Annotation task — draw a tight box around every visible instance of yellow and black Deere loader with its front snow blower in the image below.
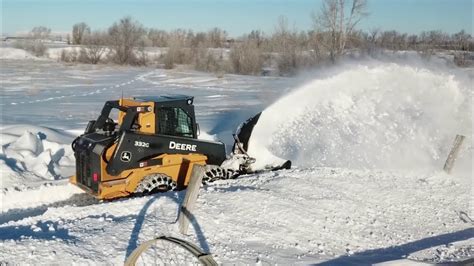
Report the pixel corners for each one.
[70,95,291,199]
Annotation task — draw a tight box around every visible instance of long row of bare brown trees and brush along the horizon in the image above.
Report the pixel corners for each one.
[12,0,474,75]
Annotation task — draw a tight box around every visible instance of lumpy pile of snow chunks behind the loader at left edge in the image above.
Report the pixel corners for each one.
[0,125,75,188]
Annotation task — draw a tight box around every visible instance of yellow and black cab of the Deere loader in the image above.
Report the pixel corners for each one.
[86,95,199,139]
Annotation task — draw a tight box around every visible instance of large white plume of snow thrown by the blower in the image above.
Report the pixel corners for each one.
[249,63,472,172]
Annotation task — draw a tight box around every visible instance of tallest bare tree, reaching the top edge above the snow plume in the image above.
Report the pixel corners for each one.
[312,0,368,61]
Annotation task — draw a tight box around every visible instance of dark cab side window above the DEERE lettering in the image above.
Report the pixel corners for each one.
[157,107,193,138]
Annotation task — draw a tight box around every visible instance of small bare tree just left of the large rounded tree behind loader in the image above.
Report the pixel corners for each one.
[81,31,107,64]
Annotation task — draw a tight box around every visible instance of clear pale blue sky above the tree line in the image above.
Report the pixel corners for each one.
[1,0,474,36]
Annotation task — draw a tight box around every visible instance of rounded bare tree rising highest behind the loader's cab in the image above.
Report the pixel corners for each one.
[109,17,145,64]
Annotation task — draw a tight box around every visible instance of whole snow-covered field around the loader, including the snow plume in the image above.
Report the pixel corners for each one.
[0,48,474,265]
